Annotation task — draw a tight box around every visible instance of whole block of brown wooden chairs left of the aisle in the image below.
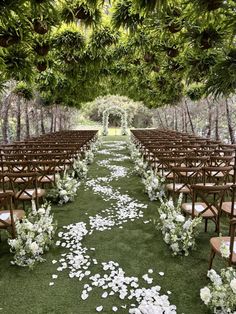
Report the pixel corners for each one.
[0,131,97,238]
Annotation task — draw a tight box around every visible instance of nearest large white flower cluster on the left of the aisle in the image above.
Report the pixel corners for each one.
[8,202,56,268]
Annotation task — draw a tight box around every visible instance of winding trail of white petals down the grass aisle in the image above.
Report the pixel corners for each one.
[49,141,176,314]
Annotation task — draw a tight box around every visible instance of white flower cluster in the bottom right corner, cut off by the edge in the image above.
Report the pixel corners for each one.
[200,267,236,314]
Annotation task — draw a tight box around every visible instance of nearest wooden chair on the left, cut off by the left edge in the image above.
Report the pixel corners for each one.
[0,193,25,238]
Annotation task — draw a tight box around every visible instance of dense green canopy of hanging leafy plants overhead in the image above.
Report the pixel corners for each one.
[0,0,236,108]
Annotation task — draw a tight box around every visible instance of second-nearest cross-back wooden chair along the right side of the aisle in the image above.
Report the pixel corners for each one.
[181,185,229,233]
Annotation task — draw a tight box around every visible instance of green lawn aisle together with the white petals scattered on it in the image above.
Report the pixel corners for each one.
[0,137,223,314]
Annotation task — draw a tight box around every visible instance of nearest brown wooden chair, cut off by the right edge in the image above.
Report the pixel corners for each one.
[209,218,236,269]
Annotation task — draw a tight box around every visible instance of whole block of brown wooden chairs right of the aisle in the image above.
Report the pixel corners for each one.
[131,129,236,268]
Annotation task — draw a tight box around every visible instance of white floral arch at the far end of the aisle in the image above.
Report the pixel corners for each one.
[102,106,128,135]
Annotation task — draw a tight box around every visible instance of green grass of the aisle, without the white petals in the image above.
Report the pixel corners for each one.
[0,136,221,314]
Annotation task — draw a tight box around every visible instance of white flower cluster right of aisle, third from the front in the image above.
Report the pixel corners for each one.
[142,170,165,201]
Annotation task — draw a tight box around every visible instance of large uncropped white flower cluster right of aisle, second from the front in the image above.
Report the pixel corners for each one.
[157,194,202,256]
